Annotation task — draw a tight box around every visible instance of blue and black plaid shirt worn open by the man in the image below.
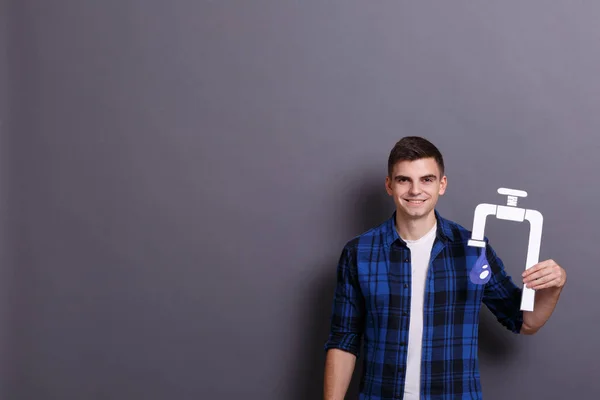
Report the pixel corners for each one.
[325,211,523,400]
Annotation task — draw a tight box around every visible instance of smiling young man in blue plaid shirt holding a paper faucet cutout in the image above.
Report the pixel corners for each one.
[324,137,566,400]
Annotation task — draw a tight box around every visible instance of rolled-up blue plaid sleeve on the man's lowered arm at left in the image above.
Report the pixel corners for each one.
[325,246,365,357]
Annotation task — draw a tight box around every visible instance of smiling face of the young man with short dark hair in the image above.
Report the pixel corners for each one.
[385,158,447,220]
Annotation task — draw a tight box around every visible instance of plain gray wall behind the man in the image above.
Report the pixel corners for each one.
[0,0,600,400]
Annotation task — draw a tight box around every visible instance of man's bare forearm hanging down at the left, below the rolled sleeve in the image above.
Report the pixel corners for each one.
[323,349,356,400]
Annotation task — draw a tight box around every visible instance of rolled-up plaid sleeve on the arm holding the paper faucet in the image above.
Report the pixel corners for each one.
[483,240,523,333]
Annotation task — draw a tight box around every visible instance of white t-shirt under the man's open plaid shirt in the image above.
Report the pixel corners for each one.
[404,223,437,400]
